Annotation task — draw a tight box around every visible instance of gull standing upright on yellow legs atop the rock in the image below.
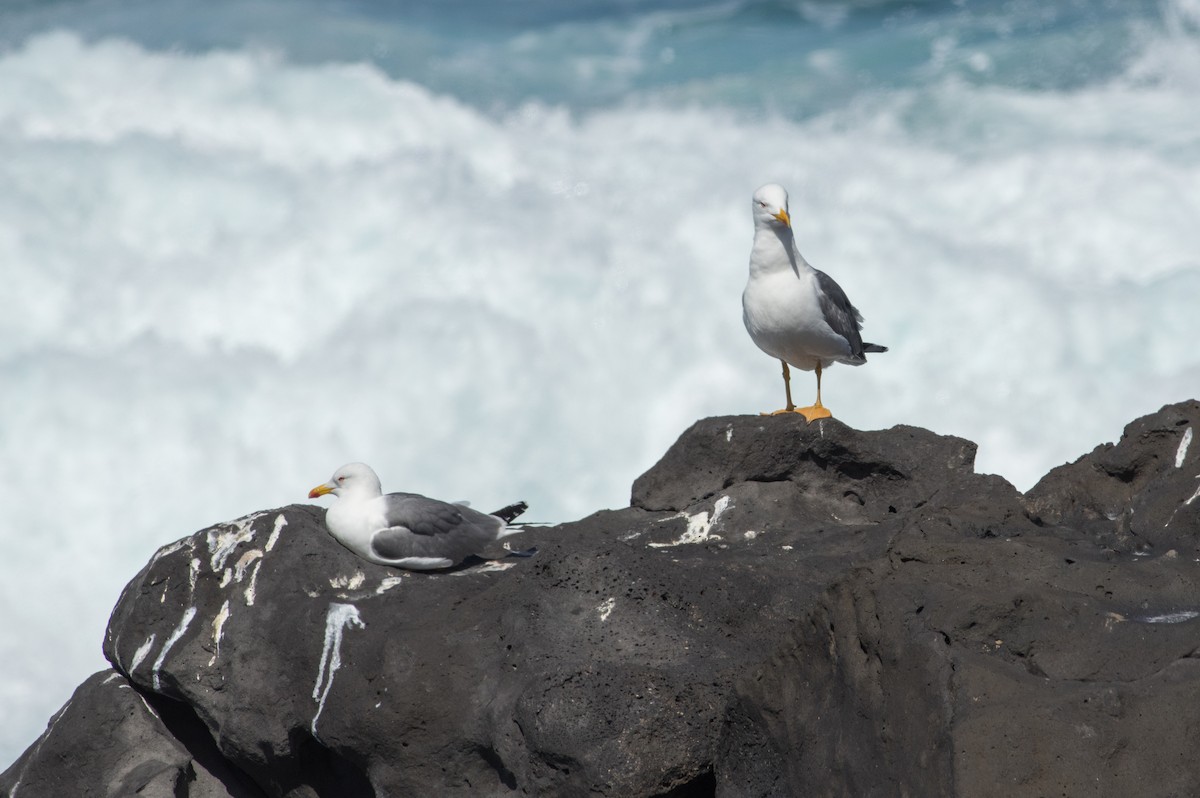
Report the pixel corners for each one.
[742,184,888,424]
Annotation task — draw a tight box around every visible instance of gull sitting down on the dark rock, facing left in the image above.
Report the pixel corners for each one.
[308,463,526,571]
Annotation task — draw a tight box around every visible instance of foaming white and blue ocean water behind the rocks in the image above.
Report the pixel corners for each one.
[0,0,1200,766]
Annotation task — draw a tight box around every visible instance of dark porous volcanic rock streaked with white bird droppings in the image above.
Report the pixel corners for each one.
[0,402,1200,798]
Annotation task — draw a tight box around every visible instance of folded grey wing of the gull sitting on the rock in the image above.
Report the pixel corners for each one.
[371,493,504,562]
